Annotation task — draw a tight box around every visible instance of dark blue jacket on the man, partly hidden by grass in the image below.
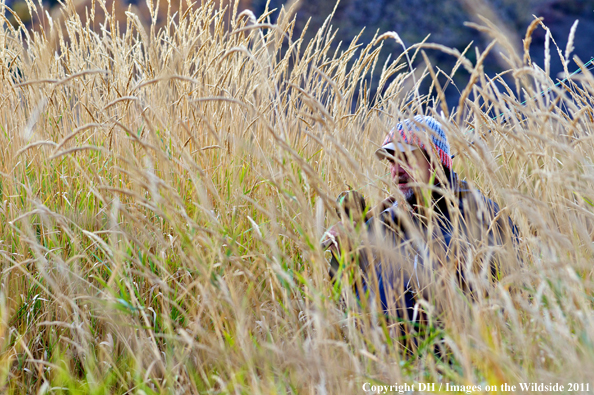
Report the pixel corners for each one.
[333,173,517,320]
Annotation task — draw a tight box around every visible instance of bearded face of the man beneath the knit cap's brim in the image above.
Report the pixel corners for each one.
[388,149,431,199]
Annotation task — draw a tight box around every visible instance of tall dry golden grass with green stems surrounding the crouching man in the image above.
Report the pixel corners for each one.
[0,0,594,394]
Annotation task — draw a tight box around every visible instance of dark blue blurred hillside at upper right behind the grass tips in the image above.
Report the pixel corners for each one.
[246,0,594,106]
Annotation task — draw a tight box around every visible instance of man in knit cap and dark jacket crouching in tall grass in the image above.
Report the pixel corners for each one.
[328,116,516,328]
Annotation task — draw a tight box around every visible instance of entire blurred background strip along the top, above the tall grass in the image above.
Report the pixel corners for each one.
[7,0,594,106]
